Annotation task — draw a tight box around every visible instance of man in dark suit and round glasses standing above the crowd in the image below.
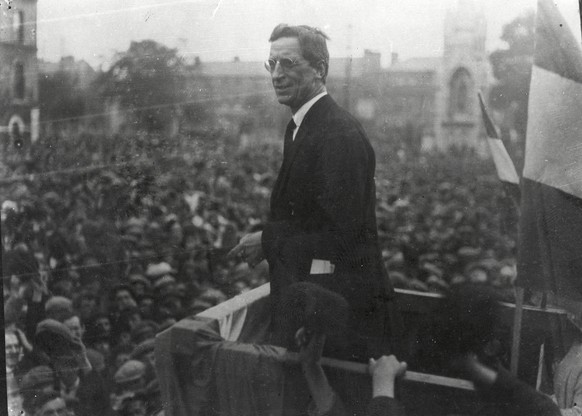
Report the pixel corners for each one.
[230,24,400,361]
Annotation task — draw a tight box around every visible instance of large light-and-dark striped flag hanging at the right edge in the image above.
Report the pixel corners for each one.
[517,0,582,305]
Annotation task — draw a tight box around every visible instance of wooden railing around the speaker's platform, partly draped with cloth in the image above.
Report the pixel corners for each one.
[156,283,566,416]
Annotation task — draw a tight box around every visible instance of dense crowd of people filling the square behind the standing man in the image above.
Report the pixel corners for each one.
[0,128,517,416]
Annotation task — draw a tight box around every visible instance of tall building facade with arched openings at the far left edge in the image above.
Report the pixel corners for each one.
[0,0,40,147]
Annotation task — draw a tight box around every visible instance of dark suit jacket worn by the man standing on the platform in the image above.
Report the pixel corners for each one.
[262,95,400,356]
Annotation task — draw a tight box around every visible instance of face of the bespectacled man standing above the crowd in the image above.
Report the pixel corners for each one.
[269,38,323,112]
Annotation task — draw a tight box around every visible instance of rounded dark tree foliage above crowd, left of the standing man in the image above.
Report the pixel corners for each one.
[97,40,185,132]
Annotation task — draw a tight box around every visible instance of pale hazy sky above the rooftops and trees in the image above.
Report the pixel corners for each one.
[37,0,580,67]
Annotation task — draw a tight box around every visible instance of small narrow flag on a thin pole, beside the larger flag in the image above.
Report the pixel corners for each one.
[478,92,520,204]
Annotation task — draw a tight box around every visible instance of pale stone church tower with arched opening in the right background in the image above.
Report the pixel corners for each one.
[437,0,489,148]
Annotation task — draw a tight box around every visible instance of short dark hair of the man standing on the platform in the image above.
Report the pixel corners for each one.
[269,23,329,84]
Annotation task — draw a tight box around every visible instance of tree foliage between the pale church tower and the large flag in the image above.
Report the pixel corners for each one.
[489,10,535,137]
